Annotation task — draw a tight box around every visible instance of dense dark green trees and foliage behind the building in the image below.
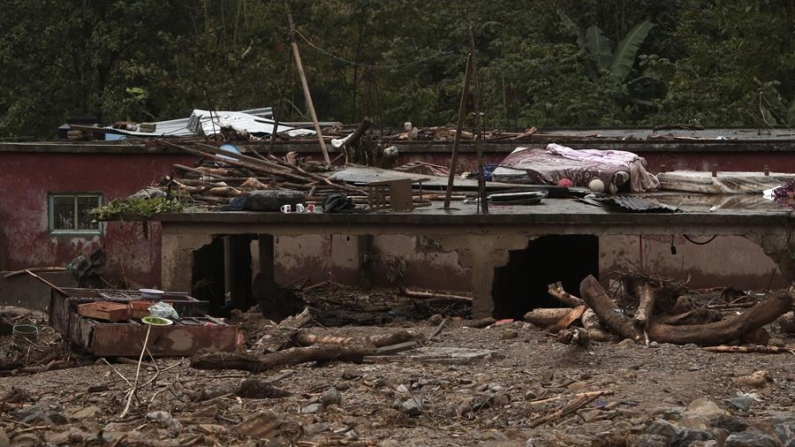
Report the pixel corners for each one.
[0,0,795,137]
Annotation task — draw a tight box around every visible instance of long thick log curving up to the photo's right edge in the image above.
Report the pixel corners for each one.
[649,292,792,346]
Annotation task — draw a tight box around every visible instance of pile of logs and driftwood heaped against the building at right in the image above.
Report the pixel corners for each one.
[524,274,795,353]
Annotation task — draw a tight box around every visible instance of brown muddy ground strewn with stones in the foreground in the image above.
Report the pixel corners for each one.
[0,288,795,447]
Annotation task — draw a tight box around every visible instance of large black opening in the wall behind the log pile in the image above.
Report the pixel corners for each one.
[491,235,599,319]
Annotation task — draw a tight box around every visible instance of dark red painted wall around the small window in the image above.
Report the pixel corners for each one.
[0,152,195,287]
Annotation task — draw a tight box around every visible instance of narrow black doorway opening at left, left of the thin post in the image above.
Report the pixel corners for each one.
[191,237,226,316]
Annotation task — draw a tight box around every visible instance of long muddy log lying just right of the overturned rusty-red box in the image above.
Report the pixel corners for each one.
[190,345,375,372]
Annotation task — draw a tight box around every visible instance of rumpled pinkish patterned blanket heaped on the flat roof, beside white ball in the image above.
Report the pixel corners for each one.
[494,143,660,192]
